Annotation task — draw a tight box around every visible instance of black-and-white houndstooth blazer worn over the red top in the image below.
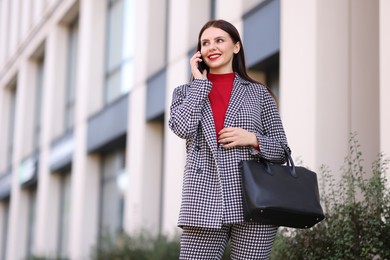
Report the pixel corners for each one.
[169,74,287,228]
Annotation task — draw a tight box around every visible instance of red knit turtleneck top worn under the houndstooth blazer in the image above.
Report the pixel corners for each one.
[207,72,235,136]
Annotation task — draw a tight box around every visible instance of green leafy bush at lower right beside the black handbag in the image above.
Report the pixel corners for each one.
[271,135,390,260]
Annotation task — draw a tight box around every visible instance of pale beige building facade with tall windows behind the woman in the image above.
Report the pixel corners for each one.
[0,0,390,260]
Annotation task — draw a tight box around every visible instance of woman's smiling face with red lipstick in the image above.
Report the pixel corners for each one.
[200,27,240,74]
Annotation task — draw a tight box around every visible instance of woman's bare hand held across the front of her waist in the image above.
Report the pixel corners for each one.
[218,127,259,148]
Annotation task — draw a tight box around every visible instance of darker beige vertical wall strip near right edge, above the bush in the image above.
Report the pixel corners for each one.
[349,0,380,169]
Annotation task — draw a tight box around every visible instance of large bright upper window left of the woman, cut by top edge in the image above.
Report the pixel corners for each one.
[105,0,135,104]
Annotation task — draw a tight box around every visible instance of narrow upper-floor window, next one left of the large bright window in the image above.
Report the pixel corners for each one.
[65,20,79,132]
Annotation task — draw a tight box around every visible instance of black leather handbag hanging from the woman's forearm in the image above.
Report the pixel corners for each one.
[240,145,325,228]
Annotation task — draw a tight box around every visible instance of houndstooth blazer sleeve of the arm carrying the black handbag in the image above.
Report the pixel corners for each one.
[251,90,291,163]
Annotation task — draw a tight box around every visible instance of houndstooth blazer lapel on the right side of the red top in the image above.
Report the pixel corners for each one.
[224,76,246,127]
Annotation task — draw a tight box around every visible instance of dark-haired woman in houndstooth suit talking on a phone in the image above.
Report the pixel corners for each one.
[169,20,287,260]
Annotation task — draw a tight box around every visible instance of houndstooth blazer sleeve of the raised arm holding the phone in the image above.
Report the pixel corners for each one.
[168,79,212,139]
